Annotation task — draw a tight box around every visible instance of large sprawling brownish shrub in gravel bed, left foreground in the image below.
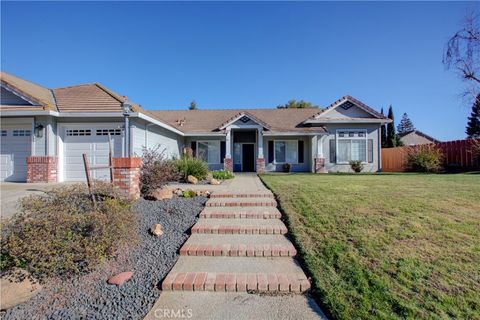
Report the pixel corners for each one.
[1,183,136,279]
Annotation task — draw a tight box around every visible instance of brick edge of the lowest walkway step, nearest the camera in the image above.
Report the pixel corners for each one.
[162,272,310,293]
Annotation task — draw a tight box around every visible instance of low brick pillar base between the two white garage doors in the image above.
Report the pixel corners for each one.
[27,156,58,183]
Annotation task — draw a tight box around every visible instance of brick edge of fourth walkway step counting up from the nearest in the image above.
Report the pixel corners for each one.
[200,207,282,219]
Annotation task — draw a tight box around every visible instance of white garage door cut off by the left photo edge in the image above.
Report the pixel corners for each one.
[0,128,32,181]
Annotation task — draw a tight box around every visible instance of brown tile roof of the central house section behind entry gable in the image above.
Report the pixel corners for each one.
[148,108,324,133]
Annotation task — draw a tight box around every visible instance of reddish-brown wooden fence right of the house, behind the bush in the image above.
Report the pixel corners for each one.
[382,139,480,172]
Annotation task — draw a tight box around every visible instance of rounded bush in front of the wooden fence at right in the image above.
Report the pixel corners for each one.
[406,144,443,172]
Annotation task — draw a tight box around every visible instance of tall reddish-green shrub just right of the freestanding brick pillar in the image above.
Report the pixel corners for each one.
[140,147,180,196]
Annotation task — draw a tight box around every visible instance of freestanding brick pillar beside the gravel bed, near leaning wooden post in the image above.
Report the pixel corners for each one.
[112,157,142,199]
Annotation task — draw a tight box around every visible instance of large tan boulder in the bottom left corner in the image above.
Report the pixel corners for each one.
[0,269,42,310]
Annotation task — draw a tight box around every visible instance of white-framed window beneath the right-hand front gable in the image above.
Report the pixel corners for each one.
[336,130,367,163]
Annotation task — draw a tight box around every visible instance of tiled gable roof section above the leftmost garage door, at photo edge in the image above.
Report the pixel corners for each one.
[0,71,56,110]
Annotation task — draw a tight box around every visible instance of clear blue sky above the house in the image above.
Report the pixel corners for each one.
[1,1,478,140]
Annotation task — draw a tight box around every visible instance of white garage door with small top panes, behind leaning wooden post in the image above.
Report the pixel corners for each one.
[63,127,123,181]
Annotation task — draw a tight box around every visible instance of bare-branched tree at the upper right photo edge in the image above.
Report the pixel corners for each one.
[443,11,480,98]
